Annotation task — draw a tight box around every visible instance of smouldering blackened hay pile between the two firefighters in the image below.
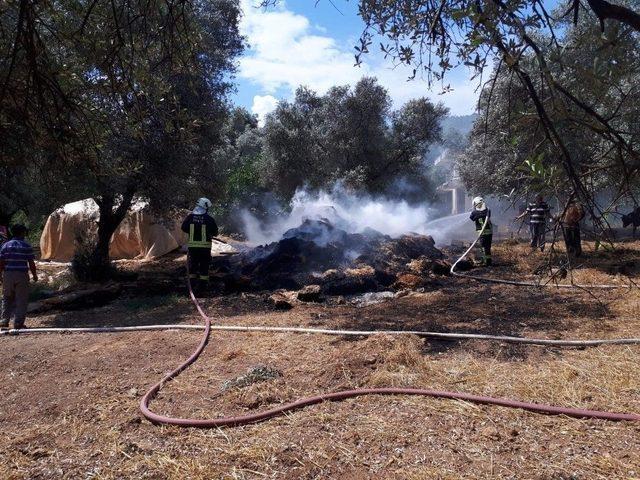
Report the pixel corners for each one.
[214,219,448,300]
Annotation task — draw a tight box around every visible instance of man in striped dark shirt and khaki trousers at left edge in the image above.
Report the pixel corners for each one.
[0,225,38,328]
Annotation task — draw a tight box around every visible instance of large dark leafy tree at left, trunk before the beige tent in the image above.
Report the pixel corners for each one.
[0,0,242,274]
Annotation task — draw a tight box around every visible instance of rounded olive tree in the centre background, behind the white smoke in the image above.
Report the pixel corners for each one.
[261,78,447,199]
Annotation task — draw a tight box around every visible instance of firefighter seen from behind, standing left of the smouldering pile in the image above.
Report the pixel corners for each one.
[182,198,218,293]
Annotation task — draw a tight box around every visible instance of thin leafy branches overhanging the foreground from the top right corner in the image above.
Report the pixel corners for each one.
[348,0,640,223]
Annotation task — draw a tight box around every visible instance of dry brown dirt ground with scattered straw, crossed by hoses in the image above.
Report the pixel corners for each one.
[0,242,640,480]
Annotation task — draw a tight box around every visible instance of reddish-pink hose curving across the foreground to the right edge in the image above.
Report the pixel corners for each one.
[140,270,640,428]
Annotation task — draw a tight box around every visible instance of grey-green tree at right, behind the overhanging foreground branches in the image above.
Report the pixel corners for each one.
[459,7,640,206]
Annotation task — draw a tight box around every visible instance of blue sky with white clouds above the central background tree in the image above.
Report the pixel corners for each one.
[233,0,477,124]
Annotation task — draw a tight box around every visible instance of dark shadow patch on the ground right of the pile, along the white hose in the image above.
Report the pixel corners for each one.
[331,283,611,360]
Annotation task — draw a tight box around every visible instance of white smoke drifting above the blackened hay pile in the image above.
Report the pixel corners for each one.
[241,184,471,245]
